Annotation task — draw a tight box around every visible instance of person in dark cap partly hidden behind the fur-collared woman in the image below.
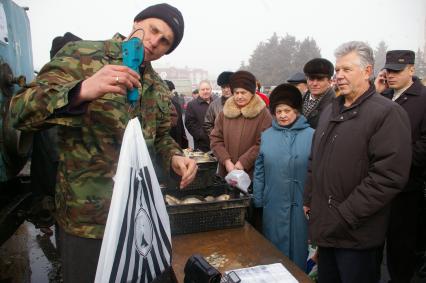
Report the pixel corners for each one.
[203,71,234,135]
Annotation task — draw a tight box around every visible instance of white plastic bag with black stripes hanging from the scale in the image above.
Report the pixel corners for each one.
[95,118,172,283]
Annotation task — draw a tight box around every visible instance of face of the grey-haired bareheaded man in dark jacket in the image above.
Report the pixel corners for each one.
[336,52,372,95]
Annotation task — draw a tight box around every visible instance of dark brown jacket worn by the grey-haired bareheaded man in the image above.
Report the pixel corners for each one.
[304,86,411,249]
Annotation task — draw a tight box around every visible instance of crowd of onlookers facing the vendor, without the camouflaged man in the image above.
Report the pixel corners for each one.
[166,45,426,282]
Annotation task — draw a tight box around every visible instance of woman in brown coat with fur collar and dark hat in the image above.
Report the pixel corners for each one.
[210,71,272,178]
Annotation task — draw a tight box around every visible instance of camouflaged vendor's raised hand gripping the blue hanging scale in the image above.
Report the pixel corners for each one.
[74,65,141,106]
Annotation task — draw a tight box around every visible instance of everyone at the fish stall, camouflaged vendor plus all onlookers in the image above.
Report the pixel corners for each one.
[10,4,426,283]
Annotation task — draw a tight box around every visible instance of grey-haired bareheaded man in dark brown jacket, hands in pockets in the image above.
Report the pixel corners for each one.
[304,41,411,283]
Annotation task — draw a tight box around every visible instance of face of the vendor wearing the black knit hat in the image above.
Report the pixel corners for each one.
[132,18,174,62]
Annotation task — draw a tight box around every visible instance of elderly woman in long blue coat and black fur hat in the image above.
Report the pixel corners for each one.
[253,84,314,270]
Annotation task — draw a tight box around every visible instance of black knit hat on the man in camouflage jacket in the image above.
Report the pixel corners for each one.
[134,3,185,54]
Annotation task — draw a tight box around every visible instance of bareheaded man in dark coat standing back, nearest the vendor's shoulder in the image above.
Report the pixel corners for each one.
[185,80,212,152]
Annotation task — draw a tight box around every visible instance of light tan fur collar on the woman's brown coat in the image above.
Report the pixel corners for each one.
[223,94,266,119]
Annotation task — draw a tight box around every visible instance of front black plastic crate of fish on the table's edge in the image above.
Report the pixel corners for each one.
[163,185,250,235]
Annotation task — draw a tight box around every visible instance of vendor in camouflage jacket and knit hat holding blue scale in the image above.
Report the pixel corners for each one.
[11,4,197,282]
